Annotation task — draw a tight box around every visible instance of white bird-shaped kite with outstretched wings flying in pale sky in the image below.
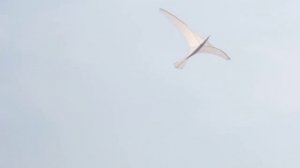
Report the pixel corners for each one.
[160,8,230,69]
